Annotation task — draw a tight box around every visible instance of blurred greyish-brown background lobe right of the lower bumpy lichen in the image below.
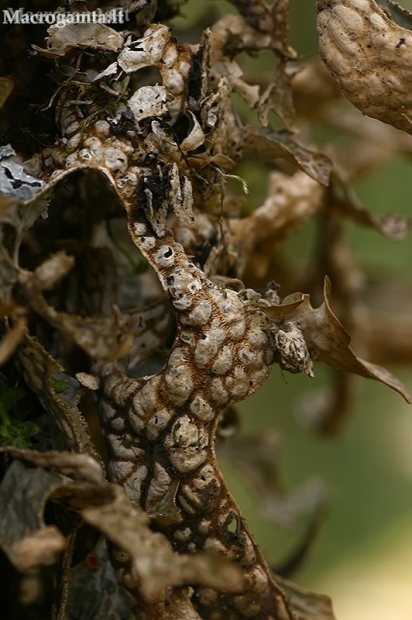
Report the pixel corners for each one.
[218,431,325,529]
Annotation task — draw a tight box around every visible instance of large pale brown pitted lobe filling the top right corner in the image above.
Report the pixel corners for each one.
[317,0,412,133]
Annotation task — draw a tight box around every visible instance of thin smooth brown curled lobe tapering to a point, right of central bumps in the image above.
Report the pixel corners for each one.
[288,278,412,403]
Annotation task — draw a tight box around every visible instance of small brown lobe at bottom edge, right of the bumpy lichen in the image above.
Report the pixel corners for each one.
[276,575,336,620]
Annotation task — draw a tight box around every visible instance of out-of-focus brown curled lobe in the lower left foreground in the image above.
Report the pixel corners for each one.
[0,448,242,612]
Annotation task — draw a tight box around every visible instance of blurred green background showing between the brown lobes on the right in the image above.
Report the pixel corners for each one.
[175,0,412,620]
